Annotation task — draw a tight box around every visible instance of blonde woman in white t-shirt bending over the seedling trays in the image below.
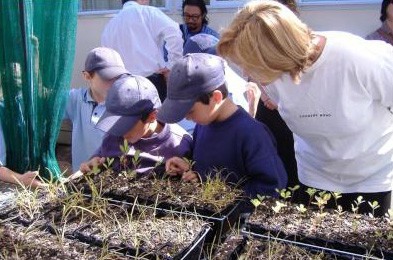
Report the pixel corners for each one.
[217,1,393,215]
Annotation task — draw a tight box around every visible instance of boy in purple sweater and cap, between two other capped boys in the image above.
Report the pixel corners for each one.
[80,75,192,173]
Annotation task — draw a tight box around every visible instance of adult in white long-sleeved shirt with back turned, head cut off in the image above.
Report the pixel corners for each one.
[101,0,183,100]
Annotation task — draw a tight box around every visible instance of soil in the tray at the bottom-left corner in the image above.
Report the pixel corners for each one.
[0,223,126,260]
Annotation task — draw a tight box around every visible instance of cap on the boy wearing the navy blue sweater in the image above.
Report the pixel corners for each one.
[157,53,225,123]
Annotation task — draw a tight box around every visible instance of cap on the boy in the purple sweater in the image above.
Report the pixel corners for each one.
[96,75,161,136]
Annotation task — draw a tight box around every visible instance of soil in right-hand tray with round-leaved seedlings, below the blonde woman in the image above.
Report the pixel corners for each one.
[247,198,393,252]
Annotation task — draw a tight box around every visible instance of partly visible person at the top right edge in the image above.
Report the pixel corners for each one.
[366,0,393,45]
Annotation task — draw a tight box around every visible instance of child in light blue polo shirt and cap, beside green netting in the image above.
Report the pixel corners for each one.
[64,47,129,172]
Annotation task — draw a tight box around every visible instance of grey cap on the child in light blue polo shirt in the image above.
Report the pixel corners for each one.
[85,47,130,80]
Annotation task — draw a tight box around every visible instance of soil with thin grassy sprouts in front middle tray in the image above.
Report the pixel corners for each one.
[36,192,205,256]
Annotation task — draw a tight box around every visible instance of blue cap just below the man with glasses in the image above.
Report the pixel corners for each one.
[183,33,219,55]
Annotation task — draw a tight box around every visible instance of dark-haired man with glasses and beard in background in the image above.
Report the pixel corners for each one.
[180,0,220,42]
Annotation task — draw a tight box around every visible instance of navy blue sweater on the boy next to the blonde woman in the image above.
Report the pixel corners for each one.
[193,107,287,197]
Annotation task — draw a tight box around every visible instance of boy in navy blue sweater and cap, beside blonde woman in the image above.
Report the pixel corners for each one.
[158,53,287,197]
